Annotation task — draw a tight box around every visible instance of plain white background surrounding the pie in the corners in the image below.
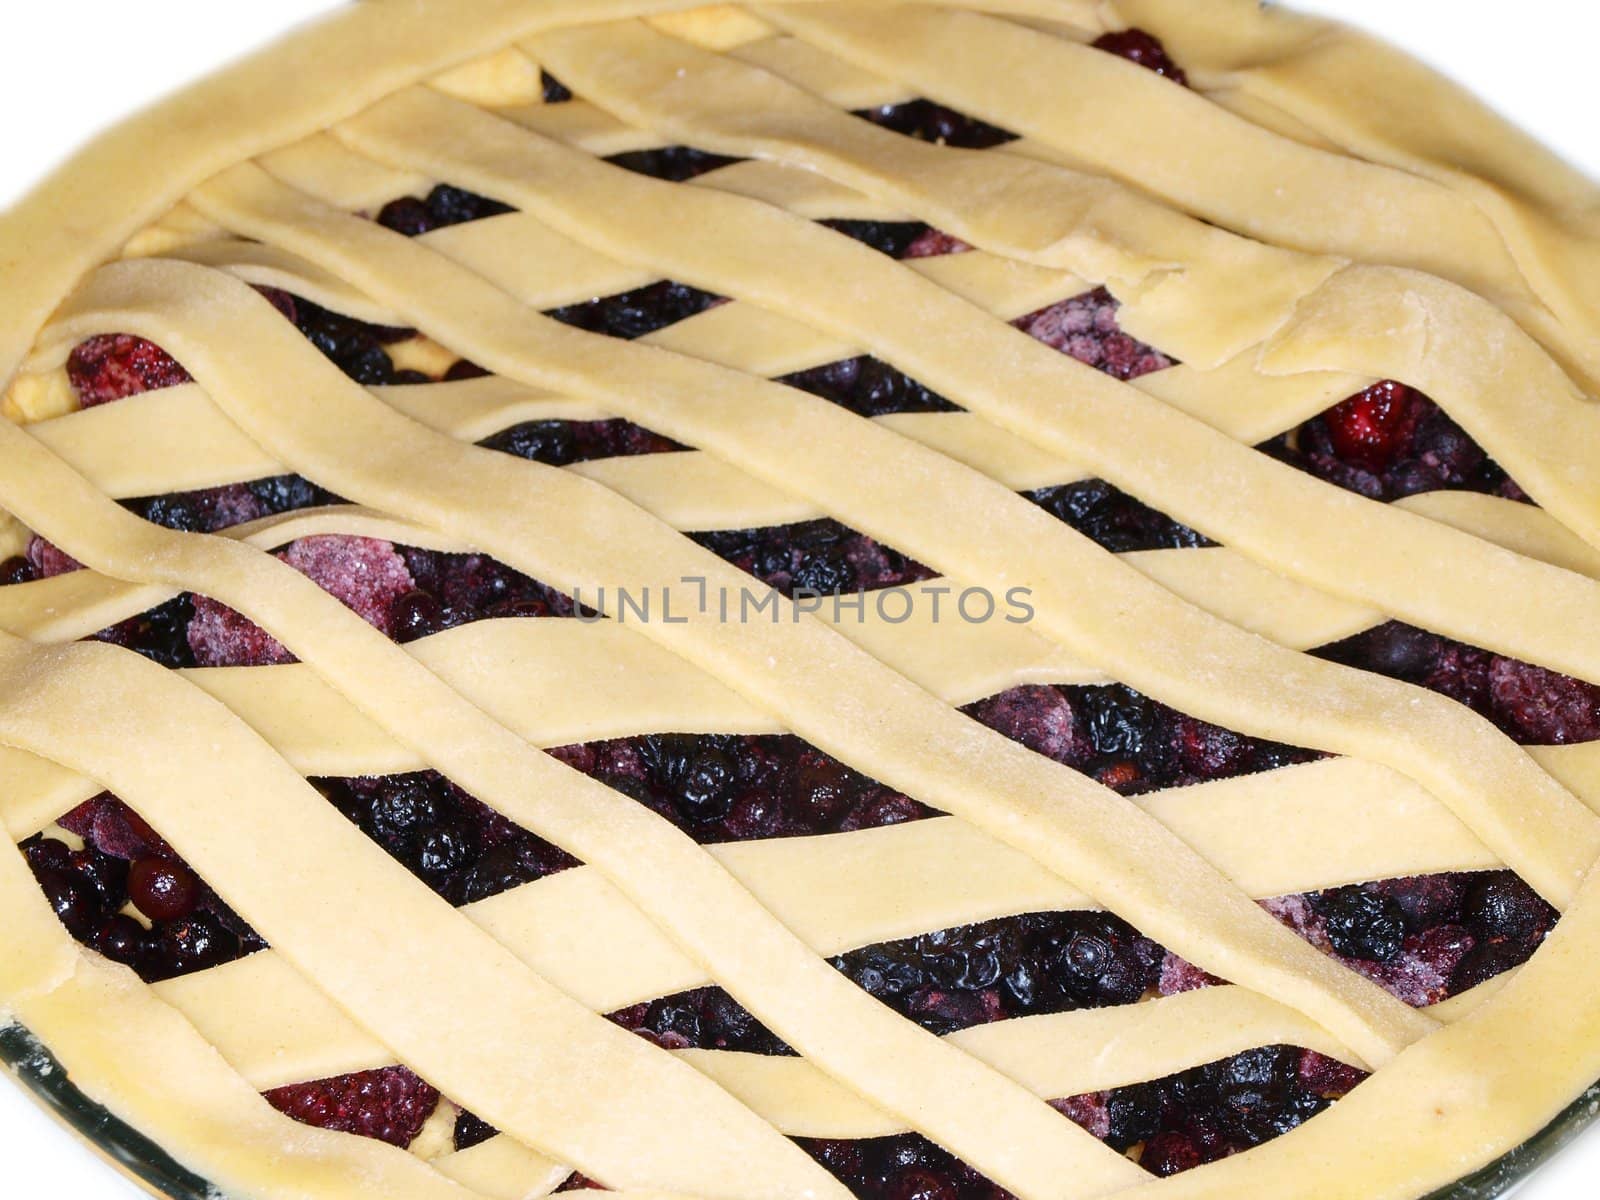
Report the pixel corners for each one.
[0,0,1600,1200]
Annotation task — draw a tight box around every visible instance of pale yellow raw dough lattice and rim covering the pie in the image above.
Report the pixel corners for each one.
[0,0,1600,1200]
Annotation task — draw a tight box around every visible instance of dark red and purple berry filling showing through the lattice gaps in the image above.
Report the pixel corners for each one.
[18,30,1568,1200]
